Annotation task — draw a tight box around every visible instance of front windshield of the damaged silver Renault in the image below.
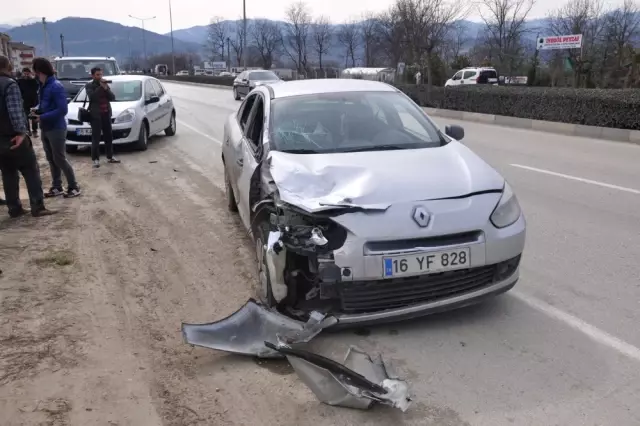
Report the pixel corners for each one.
[270,92,446,153]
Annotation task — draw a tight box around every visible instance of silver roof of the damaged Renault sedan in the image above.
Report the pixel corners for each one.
[269,78,398,98]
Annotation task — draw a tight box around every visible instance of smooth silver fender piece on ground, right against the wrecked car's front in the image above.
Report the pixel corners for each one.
[182,299,337,358]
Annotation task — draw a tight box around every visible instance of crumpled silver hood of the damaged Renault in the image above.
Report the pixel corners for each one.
[268,142,504,212]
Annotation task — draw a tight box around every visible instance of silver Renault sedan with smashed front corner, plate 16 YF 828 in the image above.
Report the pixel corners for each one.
[222,79,526,326]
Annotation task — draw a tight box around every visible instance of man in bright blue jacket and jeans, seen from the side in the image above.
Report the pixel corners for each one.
[33,58,81,198]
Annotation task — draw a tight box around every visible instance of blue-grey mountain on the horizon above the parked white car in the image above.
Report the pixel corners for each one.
[7,17,202,62]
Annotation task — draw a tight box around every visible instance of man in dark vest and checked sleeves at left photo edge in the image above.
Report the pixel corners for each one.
[0,56,55,217]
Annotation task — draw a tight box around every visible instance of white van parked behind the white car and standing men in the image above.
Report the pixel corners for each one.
[53,56,120,101]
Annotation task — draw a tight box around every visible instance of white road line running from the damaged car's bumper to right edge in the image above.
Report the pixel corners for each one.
[511,291,640,361]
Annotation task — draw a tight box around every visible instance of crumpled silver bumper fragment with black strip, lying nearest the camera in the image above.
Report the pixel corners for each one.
[265,342,411,412]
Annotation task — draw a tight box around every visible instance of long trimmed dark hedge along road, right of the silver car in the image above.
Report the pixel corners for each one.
[398,85,640,130]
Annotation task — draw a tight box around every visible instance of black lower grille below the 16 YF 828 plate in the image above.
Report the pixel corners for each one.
[340,265,498,313]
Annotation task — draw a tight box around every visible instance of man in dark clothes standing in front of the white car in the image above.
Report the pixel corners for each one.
[85,67,120,168]
